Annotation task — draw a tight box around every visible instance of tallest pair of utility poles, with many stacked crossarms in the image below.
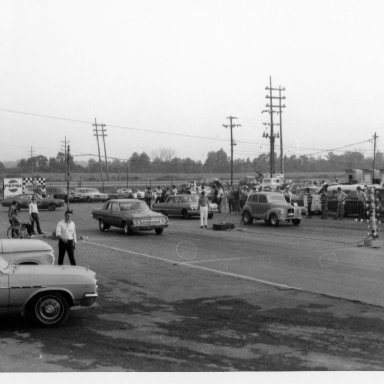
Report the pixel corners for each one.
[262,76,285,177]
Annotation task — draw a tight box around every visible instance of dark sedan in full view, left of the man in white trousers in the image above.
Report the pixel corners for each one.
[92,199,168,235]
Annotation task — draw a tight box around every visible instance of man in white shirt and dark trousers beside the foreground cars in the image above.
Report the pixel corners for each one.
[56,210,77,265]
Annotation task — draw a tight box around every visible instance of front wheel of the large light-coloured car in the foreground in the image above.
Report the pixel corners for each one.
[30,293,69,327]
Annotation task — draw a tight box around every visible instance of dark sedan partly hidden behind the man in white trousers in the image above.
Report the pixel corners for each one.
[152,194,218,219]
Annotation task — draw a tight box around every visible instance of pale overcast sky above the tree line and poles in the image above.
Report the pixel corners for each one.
[0,0,384,162]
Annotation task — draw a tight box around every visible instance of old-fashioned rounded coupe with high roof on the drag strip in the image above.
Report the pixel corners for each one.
[241,192,301,226]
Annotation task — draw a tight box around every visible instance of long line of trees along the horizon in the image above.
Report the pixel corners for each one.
[0,148,384,174]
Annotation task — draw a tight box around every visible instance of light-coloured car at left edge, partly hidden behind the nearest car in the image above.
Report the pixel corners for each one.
[0,239,55,264]
